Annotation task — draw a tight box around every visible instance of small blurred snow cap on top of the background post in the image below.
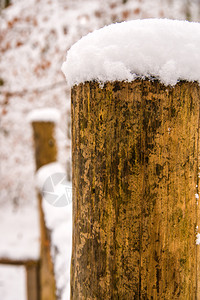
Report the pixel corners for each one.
[27,107,60,123]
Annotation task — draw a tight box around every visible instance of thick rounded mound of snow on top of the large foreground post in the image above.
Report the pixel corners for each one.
[62,19,200,86]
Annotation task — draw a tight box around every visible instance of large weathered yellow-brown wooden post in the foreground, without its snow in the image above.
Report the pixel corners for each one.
[71,80,200,300]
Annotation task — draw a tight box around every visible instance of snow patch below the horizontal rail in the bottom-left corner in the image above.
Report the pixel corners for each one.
[0,265,27,300]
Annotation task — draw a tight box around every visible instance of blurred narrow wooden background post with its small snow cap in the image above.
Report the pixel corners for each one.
[29,109,58,300]
